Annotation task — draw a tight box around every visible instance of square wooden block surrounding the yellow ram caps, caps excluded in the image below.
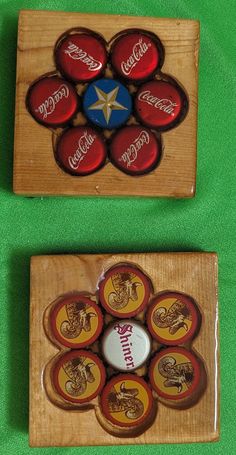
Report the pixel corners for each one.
[29,253,219,446]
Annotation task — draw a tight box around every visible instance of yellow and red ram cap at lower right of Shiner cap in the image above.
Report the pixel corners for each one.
[149,347,200,401]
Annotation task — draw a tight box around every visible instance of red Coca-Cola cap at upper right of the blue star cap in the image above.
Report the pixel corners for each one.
[111,31,163,81]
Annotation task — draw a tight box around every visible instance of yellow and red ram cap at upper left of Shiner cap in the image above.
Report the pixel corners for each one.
[50,293,103,349]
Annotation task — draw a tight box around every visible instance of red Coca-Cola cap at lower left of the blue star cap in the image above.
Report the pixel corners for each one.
[55,126,106,176]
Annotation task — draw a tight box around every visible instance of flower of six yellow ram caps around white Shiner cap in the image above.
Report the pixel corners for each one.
[44,263,206,435]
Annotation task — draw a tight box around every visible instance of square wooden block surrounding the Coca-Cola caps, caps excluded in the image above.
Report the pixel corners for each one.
[13,11,199,197]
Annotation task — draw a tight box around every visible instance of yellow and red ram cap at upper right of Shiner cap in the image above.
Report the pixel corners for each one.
[146,292,200,346]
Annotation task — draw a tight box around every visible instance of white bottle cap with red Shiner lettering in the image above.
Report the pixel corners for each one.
[102,319,151,371]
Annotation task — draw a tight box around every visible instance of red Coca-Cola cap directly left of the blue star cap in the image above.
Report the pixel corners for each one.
[26,76,79,127]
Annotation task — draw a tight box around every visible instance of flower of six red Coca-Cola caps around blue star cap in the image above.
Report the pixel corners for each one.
[26,28,188,176]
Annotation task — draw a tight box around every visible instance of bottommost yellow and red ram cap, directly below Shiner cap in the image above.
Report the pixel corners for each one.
[101,374,153,427]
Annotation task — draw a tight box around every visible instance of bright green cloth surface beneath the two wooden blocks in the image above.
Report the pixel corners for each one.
[0,0,236,455]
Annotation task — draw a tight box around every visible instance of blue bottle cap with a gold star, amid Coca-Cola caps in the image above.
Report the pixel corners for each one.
[83,78,132,129]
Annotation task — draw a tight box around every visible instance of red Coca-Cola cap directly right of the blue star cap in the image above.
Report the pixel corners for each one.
[135,80,187,131]
